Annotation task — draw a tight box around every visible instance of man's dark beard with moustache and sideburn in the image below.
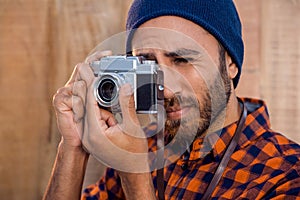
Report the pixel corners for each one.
[164,57,231,148]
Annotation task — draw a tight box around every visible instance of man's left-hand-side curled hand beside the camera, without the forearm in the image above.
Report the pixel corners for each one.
[53,51,111,147]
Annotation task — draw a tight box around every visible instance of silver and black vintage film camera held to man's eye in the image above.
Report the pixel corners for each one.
[90,56,164,114]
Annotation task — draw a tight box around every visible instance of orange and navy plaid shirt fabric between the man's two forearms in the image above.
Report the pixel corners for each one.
[81,168,125,200]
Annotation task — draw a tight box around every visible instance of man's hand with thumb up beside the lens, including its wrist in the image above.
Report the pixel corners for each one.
[73,51,155,199]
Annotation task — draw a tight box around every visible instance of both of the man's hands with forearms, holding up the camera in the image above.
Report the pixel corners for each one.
[45,52,155,199]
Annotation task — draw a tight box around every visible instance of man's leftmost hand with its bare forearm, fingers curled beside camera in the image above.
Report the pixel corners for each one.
[43,51,111,200]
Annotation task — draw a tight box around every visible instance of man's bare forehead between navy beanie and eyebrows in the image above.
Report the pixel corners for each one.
[132,16,218,56]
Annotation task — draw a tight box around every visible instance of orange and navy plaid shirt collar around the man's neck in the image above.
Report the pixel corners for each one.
[189,98,270,161]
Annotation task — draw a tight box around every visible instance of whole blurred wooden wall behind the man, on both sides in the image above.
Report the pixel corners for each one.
[0,0,300,200]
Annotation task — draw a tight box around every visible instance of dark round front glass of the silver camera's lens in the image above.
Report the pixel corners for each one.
[98,79,117,103]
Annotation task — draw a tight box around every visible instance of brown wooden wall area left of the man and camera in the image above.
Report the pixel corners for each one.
[0,0,130,200]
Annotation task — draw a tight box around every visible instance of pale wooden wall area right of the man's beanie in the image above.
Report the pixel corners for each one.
[236,0,300,142]
